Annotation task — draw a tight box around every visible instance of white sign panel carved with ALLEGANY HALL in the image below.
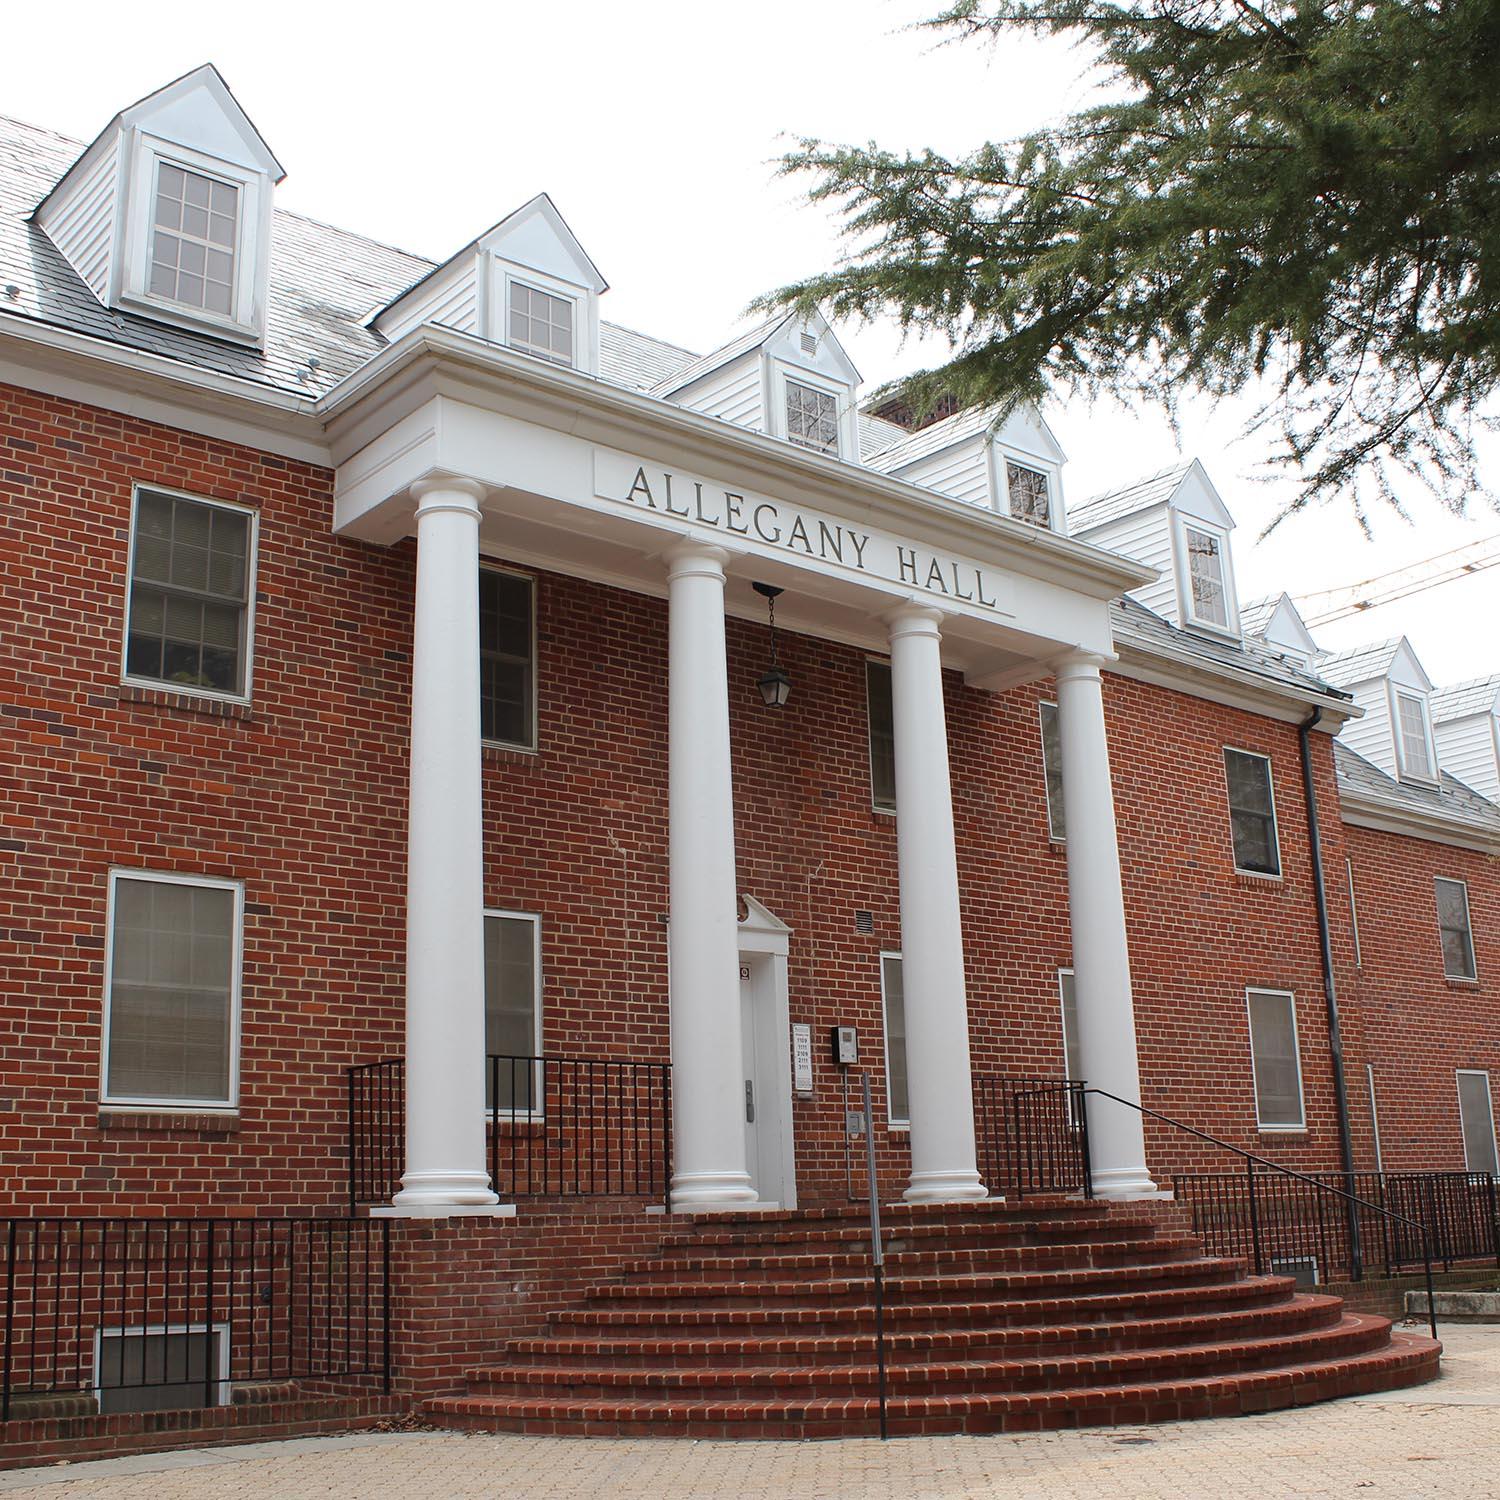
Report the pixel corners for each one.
[594,450,1011,615]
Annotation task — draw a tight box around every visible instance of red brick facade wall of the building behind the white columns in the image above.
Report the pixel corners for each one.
[0,378,1500,1214]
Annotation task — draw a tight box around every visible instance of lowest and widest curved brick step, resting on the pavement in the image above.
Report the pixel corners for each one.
[423,1334,1442,1437]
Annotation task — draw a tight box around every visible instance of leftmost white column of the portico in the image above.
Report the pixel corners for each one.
[395,479,498,1214]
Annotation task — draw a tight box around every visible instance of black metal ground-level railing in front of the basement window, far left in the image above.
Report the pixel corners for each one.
[0,1218,392,1422]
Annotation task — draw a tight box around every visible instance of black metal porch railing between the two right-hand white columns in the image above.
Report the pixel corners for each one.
[974,1073,1094,1199]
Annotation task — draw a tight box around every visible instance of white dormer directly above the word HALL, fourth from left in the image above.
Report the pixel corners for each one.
[869,405,1068,536]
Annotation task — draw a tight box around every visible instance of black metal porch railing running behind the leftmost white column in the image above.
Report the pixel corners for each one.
[348,1053,672,1214]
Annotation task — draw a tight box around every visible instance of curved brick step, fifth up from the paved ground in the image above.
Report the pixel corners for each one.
[584,1256,1244,1302]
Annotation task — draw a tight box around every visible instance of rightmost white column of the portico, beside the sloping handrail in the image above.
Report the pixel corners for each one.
[1055,651,1157,1199]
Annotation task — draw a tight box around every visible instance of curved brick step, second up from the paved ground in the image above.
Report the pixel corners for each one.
[464,1313,1391,1395]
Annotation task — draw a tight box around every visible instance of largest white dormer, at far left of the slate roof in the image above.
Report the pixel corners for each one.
[35,63,285,344]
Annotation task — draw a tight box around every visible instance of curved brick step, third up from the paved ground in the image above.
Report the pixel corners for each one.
[497,1298,1343,1370]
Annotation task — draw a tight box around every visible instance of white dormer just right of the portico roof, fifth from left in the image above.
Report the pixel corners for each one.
[1070,459,1241,641]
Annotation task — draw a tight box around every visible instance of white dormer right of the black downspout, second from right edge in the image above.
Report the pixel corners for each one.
[1317,636,1440,786]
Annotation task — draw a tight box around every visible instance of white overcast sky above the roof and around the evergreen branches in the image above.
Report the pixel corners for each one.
[0,0,1500,683]
